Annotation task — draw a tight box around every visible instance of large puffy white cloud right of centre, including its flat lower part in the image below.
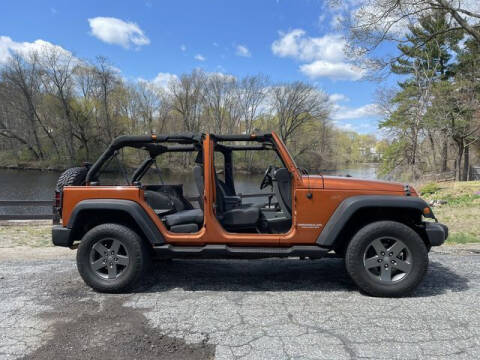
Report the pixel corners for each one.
[272,29,365,80]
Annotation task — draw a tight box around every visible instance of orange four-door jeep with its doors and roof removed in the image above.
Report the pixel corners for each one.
[52,133,448,296]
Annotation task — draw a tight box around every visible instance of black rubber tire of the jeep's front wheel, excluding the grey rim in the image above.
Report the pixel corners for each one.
[345,221,428,297]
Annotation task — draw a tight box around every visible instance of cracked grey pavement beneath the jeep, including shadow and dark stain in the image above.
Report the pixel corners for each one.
[0,253,480,359]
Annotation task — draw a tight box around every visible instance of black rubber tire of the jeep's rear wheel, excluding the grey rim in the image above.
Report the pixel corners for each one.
[77,224,151,293]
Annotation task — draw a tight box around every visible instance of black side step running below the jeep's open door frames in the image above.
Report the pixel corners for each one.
[153,244,330,259]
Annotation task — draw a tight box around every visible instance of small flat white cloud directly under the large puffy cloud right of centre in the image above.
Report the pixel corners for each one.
[300,60,365,80]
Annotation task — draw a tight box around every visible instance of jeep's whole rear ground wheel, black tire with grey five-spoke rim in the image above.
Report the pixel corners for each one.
[77,224,150,293]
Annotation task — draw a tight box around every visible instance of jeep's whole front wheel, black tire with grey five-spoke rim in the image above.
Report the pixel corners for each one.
[345,221,428,297]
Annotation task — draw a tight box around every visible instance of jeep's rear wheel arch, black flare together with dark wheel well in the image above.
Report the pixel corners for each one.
[67,199,165,245]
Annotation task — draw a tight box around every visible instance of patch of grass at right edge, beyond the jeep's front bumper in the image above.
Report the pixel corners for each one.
[419,181,480,244]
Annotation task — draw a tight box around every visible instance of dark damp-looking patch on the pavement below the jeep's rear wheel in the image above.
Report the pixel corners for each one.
[23,292,215,360]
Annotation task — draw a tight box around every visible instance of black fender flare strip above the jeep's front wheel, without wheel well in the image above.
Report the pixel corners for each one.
[316,195,435,247]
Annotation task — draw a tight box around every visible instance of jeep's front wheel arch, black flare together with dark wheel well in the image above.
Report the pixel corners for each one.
[316,195,433,252]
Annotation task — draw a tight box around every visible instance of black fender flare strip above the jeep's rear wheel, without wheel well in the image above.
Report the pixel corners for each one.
[67,199,165,245]
